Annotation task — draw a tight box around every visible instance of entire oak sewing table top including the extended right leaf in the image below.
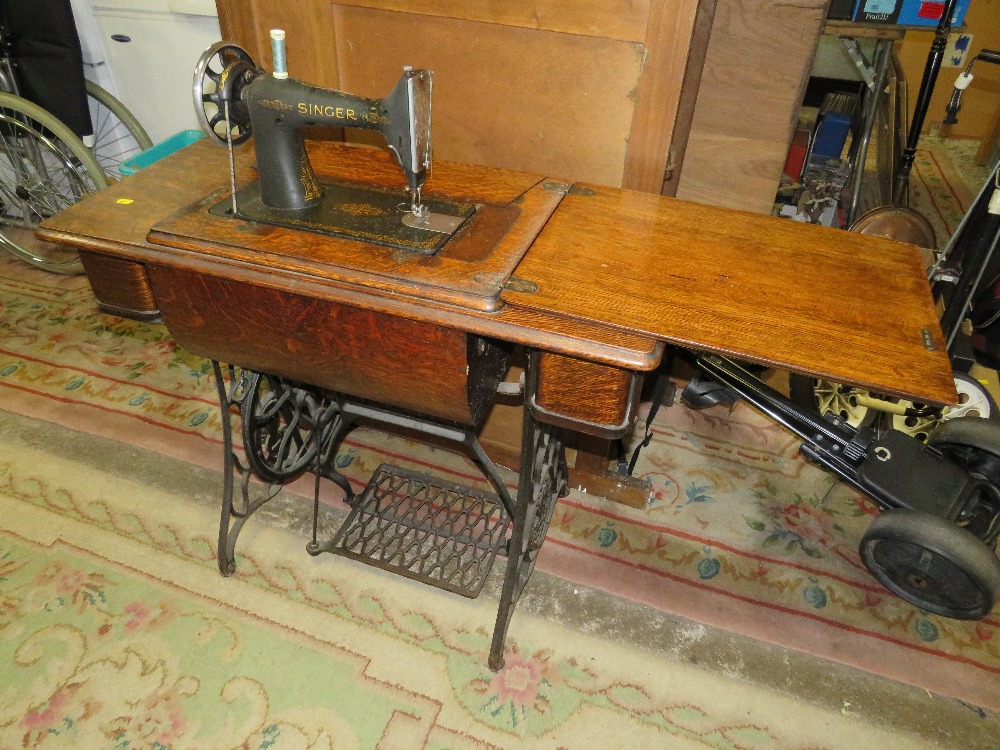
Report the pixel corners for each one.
[39,135,955,403]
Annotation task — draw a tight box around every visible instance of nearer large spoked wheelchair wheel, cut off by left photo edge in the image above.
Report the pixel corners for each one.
[0,93,107,274]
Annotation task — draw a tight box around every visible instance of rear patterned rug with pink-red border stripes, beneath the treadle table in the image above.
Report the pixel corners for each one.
[0,242,1000,724]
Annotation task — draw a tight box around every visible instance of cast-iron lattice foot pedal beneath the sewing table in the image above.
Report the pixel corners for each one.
[321,464,508,598]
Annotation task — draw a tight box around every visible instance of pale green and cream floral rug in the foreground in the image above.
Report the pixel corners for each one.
[0,440,968,750]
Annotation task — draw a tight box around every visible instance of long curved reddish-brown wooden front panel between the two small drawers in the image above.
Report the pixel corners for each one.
[149,266,507,425]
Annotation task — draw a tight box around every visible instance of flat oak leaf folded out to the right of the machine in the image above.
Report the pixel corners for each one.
[502,186,955,403]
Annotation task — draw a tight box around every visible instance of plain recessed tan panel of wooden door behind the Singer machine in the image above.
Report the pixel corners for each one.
[334,6,642,185]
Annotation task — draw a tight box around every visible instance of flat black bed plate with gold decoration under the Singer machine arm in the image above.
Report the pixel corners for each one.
[209,180,476,255]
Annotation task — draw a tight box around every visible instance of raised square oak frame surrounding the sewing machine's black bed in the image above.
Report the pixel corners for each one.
[148,142,568,311]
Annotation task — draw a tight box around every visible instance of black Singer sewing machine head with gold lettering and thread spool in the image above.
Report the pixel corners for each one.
[194,30,474,252]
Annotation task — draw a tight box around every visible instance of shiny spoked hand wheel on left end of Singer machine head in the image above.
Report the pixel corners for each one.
[193,42,257,146]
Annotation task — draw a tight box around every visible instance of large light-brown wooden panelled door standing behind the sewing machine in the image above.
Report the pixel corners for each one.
[217,0,704,192]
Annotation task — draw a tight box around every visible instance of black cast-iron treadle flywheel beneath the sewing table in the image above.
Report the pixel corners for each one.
[240,373,335,484]
